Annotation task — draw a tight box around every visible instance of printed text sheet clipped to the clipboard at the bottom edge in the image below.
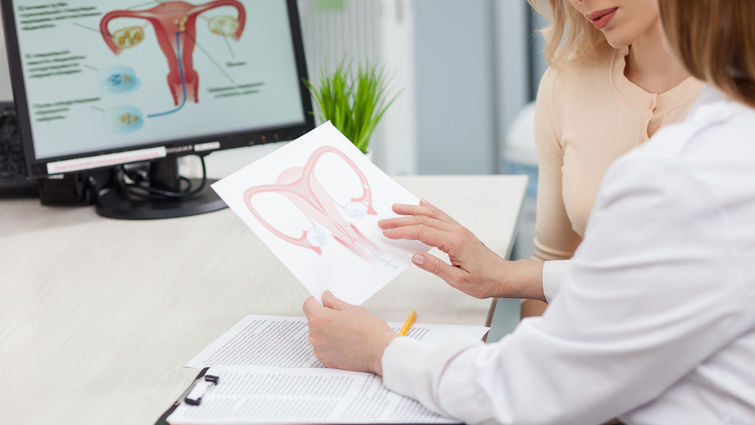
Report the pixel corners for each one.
[168,368,458,424]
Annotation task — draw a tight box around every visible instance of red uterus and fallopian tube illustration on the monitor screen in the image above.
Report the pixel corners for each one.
[100,0,246,111]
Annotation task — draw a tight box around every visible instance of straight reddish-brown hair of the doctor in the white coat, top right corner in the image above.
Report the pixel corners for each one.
[659,0,755,107]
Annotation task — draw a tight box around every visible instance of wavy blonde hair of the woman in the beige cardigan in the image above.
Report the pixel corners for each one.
[529,0,613,68]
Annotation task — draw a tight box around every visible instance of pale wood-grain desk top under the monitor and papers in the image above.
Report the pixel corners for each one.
[0,176,526,425]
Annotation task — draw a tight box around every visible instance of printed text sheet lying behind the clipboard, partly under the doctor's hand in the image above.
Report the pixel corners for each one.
[186,315,488,369]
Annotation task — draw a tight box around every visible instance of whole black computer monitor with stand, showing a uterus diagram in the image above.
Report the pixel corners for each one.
[2,0,314,218]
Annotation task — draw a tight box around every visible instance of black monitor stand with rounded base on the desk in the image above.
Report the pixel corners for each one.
[97,158,227,220]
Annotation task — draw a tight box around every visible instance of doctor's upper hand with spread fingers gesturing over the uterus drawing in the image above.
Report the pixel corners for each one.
[378,200,545,300]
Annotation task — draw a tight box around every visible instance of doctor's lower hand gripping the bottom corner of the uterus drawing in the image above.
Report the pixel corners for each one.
[304,291,398,375]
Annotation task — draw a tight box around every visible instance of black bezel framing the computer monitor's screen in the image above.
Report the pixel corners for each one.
[2,0,315,178]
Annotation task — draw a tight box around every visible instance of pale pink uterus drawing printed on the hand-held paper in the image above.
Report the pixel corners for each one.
[244,146,396,268]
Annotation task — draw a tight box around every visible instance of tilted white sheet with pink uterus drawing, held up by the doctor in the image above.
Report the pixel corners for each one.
[212,122,429,304]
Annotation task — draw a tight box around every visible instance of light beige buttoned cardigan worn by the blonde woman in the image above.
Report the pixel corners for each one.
[534,45,704,260]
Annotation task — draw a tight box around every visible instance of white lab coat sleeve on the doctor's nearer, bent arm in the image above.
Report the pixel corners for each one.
[383,154,747,425]
